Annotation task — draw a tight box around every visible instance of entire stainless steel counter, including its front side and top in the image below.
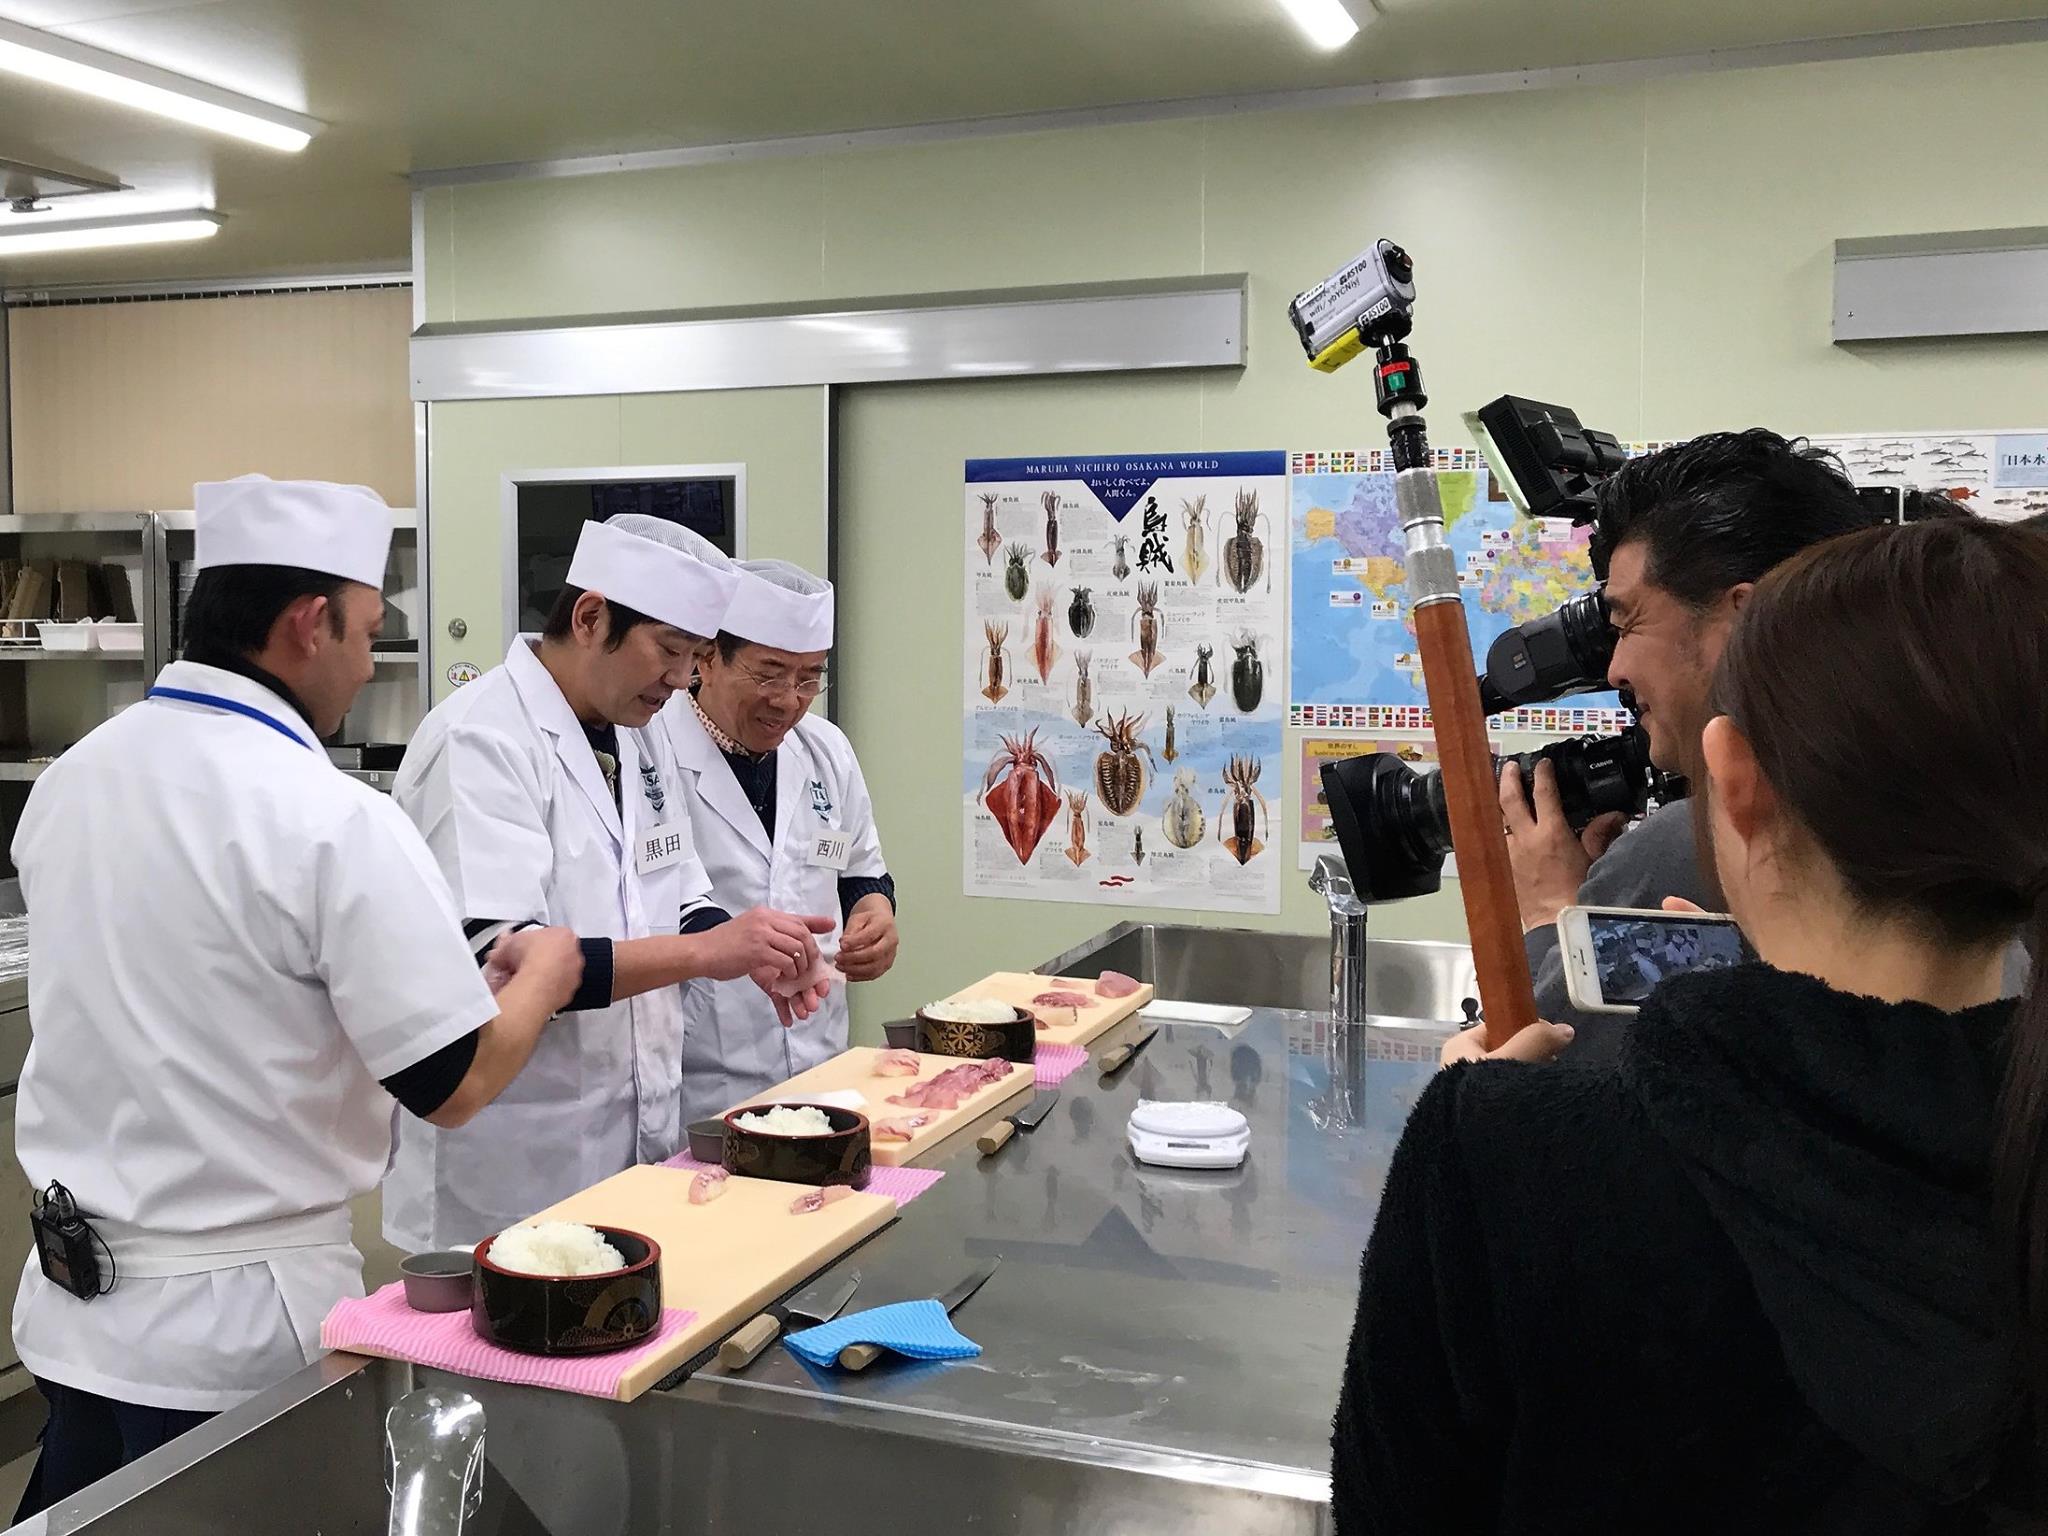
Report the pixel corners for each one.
[8,930,1454,1536]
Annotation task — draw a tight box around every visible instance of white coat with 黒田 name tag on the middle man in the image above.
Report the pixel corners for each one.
[383,635,711,1249]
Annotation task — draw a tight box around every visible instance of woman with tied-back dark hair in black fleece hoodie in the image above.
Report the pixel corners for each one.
[1331,520,2048,1536]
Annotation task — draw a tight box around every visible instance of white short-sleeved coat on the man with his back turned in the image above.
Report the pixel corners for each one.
[10,662,498,1413]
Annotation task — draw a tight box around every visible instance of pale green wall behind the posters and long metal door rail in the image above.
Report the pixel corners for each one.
[426,45,2048,1036]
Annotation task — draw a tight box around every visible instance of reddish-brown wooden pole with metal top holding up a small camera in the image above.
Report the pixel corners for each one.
[1360,325,1536,1049]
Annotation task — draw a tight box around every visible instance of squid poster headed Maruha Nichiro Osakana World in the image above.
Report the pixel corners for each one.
[961,453,1288,911]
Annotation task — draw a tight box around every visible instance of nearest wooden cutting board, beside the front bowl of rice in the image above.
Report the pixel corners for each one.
[535,1165,897,1403]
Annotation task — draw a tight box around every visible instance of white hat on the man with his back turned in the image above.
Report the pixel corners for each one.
[193,475,391,588]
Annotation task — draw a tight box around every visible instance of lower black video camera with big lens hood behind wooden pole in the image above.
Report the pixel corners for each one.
[1323,725,1686,901]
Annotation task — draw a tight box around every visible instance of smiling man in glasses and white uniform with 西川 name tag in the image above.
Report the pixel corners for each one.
[662,559,897,1120]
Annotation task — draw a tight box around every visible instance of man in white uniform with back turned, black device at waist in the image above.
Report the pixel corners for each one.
[14,475,582,1516]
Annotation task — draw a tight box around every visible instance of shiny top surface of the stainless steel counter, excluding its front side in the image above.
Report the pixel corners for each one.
[682,1010,1436,1481]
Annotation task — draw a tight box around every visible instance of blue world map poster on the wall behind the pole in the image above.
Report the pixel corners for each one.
[1288,449,1628,733]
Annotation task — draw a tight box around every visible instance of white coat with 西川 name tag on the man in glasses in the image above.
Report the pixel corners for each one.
[659,694,889,1124]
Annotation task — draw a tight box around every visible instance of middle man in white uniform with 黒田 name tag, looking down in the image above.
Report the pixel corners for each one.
[383,522,836,1249]
